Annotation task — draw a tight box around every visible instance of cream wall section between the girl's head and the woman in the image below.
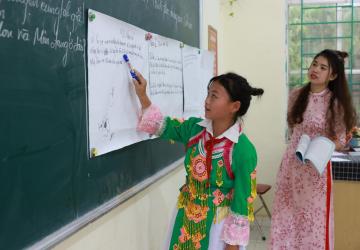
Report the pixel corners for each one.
[221,0,287,211]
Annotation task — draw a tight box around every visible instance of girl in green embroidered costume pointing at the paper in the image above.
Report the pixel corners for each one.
[134,72,264,250]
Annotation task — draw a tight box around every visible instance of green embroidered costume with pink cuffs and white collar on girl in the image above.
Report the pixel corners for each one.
[138,105,257,250]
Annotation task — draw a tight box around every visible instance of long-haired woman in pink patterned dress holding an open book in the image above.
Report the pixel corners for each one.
[270,50,356,250]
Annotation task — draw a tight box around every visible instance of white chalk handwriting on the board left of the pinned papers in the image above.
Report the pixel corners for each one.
[0,0,86,67]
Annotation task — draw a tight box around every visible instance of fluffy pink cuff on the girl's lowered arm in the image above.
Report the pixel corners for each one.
[221,211,250,246]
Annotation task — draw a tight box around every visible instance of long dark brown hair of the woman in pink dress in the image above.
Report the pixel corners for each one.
[287,49,356,138]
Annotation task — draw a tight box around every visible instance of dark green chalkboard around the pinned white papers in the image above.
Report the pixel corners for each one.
[0,0,199,249]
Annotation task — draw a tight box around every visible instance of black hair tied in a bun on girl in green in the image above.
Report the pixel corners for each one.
[208,72,264,117]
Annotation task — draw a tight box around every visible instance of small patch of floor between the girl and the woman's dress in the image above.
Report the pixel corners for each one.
[246,215,270,250]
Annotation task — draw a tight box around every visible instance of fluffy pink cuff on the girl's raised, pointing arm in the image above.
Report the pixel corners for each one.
[137,104,164,135]
